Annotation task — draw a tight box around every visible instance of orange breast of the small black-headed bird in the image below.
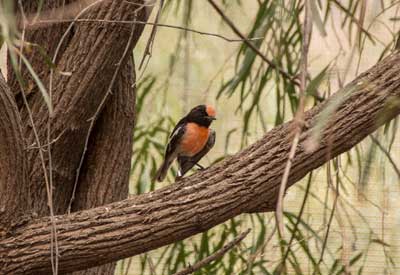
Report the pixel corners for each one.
[179,122,210,157]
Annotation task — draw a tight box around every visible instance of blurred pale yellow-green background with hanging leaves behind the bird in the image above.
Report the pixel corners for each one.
[111,0,400,275]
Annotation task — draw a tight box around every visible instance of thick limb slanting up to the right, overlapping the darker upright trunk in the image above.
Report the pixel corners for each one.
[18,0,146,216]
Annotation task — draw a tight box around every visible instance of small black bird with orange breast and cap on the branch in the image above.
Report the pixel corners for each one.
[155,105,216,181]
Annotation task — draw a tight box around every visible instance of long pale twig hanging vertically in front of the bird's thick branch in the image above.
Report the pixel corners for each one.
[276,0,312,237]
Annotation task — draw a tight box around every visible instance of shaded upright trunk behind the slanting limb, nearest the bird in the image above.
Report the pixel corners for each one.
[68,58,135,275]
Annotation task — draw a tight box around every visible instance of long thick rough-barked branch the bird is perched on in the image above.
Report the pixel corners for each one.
[0,52,400,274]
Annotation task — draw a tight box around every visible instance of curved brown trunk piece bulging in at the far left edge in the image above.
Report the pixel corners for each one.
[0,73,28,237]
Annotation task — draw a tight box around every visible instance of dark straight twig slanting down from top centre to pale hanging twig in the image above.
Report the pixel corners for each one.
[208,0,299,86]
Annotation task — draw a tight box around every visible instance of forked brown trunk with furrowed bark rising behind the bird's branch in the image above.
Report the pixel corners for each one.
[4,0,148,274]
